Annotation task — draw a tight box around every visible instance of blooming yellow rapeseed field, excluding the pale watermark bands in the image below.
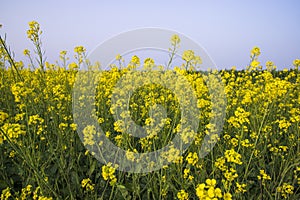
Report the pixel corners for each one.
[0,21,300,200]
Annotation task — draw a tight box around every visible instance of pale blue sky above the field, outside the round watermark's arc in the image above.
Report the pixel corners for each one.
[0,0,300,69]
